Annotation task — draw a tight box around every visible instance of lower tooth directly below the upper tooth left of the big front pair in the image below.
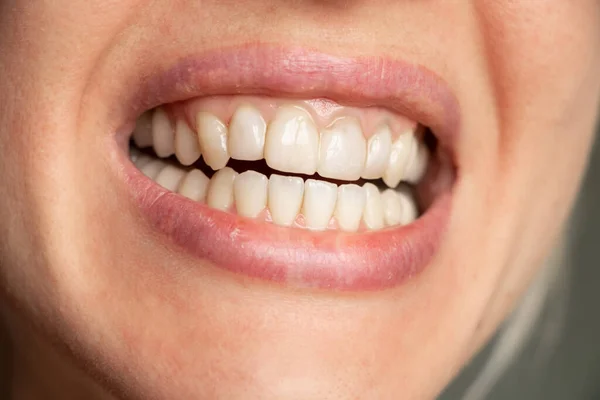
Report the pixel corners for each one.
[233,171,269,218]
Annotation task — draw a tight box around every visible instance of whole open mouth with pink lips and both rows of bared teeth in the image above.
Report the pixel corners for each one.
[115,46,460,291]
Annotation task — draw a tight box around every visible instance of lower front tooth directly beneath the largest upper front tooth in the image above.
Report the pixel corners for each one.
[269,174,304,226]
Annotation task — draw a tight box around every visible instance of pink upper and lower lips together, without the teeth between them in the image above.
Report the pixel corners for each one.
[115,45,460,291]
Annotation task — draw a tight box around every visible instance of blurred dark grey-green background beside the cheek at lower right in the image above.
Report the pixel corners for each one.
[440,127,600,400]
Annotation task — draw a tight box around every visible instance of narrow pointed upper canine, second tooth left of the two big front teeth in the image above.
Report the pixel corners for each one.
[196,112,229,171]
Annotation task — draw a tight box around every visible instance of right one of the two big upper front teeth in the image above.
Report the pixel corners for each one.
[317,117,367,181]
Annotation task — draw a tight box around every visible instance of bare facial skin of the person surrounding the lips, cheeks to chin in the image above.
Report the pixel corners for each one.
[0,0,600,399]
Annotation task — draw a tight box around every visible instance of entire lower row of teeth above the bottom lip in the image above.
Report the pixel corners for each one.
[130,147,418,232]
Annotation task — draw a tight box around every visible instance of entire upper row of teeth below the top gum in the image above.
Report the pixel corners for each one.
[133,104,428,187]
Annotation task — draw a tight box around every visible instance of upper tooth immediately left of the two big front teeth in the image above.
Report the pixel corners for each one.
[228,105,267,161]
